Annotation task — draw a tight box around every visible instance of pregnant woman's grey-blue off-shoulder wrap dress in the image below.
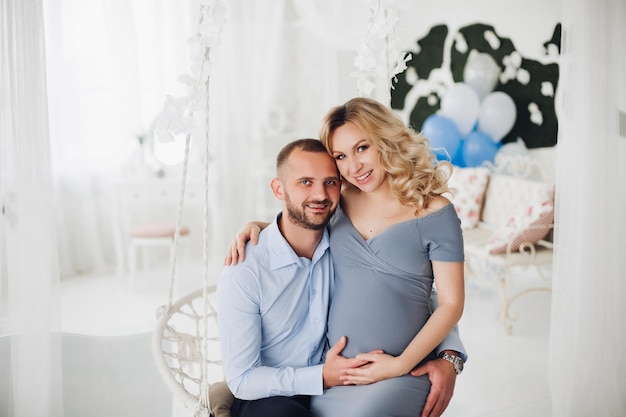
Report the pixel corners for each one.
[312,204,463,417]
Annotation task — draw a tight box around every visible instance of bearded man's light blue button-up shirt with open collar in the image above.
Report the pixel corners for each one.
[218,215,333,400]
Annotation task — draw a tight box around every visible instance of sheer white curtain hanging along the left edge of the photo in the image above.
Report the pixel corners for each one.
[0,0,63,417]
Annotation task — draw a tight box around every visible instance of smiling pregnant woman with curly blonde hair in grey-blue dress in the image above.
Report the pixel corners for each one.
[311,98,464,417]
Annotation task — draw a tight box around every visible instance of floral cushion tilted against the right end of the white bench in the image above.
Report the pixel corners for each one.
[487,198,554,255]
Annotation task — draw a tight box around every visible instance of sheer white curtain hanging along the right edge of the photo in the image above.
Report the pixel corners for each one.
[549,0,626,417]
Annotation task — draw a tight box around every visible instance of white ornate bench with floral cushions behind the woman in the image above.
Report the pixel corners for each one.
[450,157,554,333]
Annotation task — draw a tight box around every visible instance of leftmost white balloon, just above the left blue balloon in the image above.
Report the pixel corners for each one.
[439,83,480,136]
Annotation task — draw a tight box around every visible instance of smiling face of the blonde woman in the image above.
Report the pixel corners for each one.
[330,122,386,192]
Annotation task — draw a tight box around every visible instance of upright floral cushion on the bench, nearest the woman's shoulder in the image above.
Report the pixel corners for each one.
[448,166,489,229]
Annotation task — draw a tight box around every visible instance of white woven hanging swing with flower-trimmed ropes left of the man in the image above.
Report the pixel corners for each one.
[152,1,224,417]
